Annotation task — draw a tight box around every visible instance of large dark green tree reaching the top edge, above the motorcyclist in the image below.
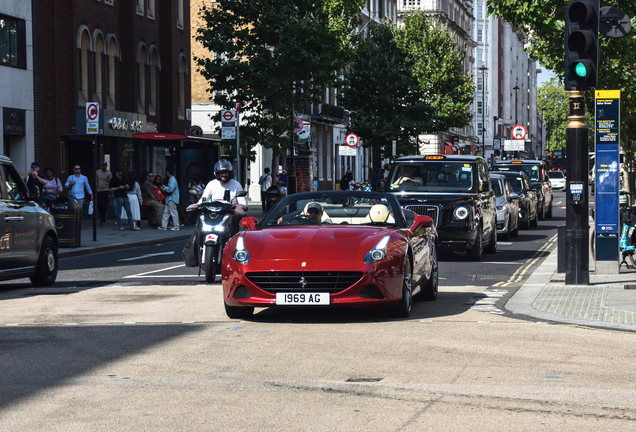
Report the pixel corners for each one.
[195,0,364,157]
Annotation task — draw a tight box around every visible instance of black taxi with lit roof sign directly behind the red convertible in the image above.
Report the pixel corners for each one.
[385,155,497,261]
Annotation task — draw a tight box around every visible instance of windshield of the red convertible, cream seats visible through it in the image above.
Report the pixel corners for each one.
[259,191,404,228]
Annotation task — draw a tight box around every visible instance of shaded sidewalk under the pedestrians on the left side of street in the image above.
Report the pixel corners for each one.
[58,201,263,258]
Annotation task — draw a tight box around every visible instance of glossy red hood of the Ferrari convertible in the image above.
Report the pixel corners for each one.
[244,225,395,261]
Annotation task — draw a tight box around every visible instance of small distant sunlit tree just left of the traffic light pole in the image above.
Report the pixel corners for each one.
[537,78,570,151]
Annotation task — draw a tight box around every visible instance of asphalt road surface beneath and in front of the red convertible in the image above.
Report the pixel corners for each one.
[6,196,636,431]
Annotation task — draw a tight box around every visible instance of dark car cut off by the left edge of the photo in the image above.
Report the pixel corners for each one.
[0,155,58,286]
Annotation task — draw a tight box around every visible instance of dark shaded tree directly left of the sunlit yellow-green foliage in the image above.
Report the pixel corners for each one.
[342,23,432,157]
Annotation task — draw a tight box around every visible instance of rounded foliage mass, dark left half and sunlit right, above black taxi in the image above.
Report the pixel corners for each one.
[344,12,474,157]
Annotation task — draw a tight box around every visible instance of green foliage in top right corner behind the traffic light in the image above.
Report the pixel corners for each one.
[487,0,636,139]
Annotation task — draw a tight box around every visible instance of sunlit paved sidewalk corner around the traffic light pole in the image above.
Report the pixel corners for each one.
[505,245,636,331]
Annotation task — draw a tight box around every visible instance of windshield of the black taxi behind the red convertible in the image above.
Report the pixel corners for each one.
[389,161,477,192]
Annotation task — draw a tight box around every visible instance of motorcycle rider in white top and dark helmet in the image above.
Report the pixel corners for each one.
[197,159,247,233]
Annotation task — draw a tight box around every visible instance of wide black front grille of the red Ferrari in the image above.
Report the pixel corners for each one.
[245,271,362,294]
